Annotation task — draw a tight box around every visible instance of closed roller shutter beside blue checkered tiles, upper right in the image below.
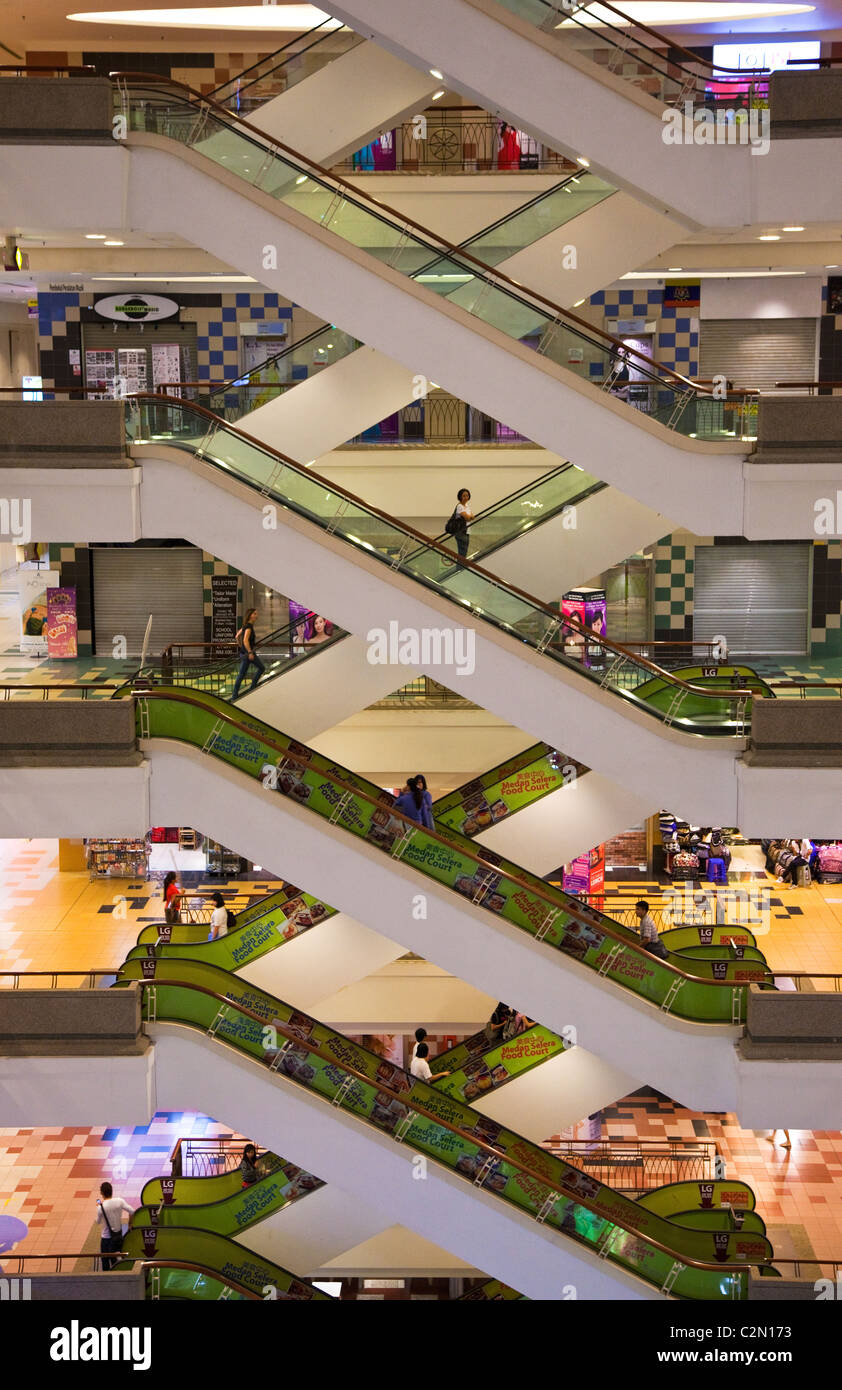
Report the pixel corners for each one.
[699,318,817,391]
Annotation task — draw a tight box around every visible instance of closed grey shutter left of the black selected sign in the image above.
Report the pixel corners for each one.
[93,546,204,656]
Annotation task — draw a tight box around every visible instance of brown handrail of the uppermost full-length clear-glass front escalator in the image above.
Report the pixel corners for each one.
[108,71,714,399]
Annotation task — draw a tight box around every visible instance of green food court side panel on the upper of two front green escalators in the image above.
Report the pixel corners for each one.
[138,688,753,1023]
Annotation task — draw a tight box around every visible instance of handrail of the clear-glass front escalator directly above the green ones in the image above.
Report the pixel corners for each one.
[126,391,752,701]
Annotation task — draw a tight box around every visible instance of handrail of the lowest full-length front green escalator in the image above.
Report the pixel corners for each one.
[135,958,771,1273]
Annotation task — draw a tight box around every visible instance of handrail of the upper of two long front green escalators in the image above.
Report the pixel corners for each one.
[135,687,761,990]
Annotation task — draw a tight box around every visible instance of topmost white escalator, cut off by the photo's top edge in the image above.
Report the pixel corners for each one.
[325,0,839,229]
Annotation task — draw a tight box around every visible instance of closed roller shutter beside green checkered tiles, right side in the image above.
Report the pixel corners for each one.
[693,541,810,656]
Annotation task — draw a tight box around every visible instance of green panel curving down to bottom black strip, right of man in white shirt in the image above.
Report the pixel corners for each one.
[122,1226,329,1301]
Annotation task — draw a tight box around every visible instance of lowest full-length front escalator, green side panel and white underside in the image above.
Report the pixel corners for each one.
[112,960,773,1300]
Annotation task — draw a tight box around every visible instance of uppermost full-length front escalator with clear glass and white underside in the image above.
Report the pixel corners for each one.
[10,79,761,534]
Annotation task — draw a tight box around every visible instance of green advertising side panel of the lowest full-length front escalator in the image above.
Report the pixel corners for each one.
[126,960,768,1298]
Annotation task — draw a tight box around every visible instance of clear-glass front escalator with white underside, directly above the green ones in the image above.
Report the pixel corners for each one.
[129,398,783,834]
